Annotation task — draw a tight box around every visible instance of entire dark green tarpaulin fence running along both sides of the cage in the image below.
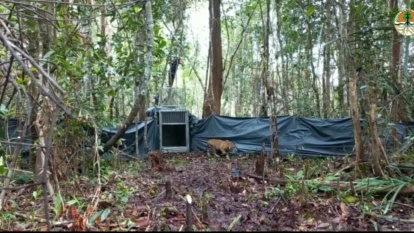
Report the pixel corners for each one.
[3,112,414,157]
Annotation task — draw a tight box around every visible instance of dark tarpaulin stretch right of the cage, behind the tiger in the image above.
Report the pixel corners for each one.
[191,116,354,156]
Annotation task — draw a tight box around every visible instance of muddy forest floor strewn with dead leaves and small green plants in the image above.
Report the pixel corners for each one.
[0,154,414,231]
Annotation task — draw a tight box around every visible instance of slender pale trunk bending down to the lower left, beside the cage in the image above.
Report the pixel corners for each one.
[104,0,154,151]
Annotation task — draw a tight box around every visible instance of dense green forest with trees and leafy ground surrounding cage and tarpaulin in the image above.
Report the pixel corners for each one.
[0,0,414,231]
